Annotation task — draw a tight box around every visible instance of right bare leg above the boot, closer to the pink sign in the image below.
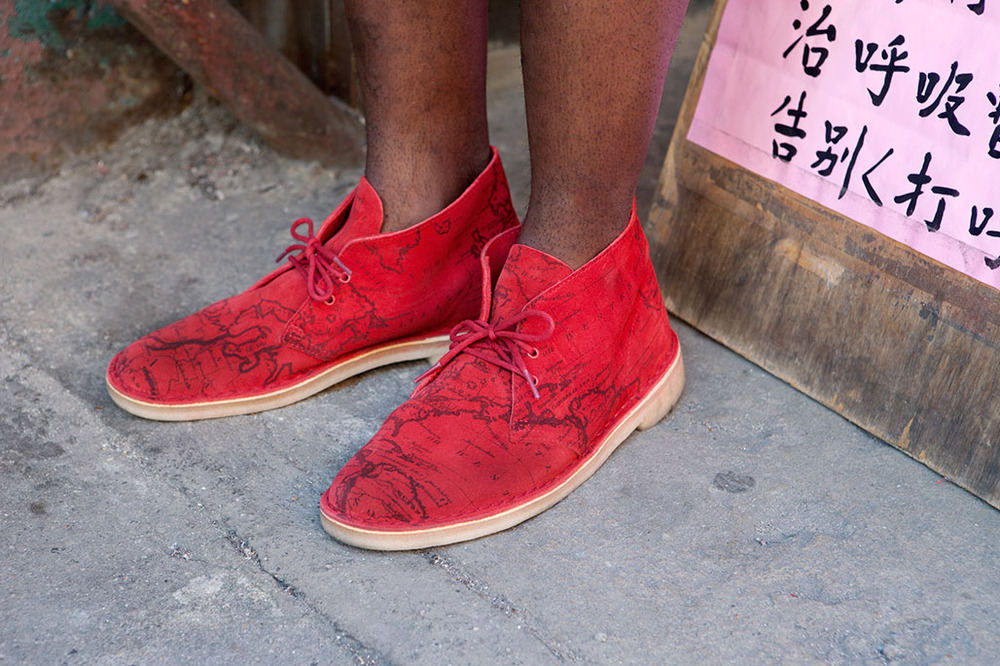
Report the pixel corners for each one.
[520,0,687,268]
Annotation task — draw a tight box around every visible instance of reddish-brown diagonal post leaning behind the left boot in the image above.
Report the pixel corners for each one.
[110,0,364,165]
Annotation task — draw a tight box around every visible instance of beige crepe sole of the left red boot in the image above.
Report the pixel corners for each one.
[105,335,451,421]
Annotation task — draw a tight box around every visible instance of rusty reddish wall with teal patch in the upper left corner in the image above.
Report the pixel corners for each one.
[0,0,190,181]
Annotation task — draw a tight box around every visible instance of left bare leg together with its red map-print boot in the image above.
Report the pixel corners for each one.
[107,0,517,420]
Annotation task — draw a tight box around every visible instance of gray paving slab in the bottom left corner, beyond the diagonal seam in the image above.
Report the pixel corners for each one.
[0,338,380,663]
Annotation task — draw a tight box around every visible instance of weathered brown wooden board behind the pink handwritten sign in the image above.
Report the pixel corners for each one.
[648,0,1000,508]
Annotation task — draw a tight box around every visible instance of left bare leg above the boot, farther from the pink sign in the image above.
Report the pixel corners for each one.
[345,0,490,231]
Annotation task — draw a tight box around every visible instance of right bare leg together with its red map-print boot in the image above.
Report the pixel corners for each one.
[321,0,684,550]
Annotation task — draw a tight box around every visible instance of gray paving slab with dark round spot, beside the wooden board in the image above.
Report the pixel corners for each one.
[444,327,1000,663]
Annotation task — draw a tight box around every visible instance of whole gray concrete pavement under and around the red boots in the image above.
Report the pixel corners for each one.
[0,2,1000,664]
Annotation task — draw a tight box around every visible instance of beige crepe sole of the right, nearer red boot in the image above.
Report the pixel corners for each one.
[320,349,684,550]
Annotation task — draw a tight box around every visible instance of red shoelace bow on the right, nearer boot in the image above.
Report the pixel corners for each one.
[416,310,556,398]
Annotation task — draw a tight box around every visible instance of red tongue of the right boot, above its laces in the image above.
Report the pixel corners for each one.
[490,245,573,322]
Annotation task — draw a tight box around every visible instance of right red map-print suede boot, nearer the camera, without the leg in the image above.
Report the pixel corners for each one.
[320,205,684,550]
